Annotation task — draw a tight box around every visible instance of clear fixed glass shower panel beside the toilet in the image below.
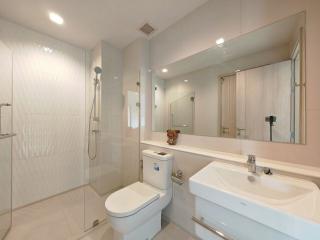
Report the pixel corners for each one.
[84,59,140,230]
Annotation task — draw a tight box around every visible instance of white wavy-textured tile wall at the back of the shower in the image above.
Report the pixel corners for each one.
[0,20,86,207]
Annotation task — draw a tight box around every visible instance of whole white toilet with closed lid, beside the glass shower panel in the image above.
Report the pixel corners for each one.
[105,150,173,240]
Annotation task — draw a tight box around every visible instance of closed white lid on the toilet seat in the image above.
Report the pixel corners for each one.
[105,182,160,217]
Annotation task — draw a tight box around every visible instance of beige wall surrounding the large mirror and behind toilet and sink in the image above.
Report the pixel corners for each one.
[142,0,320,236]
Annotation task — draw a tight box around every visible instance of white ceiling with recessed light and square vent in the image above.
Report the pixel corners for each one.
[0,0,207,48]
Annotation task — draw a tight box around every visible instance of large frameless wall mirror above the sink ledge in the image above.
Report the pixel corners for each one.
[152,12,306,144]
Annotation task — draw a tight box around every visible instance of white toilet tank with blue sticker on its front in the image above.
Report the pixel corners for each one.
[142,150,173,190]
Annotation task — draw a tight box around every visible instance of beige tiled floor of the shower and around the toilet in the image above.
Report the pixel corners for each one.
[6,187,194,240]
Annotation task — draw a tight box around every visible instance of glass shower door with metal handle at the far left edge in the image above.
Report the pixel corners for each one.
[0,41,13,239]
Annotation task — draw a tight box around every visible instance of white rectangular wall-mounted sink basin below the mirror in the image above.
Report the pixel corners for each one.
[189,162,320,240]
